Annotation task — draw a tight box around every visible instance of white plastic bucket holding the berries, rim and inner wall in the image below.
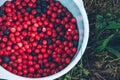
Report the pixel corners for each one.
[0,0,89,80]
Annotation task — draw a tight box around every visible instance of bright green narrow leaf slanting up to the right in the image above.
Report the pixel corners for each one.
[97,34,114,51]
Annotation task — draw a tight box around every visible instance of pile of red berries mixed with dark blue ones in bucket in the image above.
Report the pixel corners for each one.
[0,0,79,78]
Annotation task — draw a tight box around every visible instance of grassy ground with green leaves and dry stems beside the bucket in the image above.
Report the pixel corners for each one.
[58,0,120,80]
